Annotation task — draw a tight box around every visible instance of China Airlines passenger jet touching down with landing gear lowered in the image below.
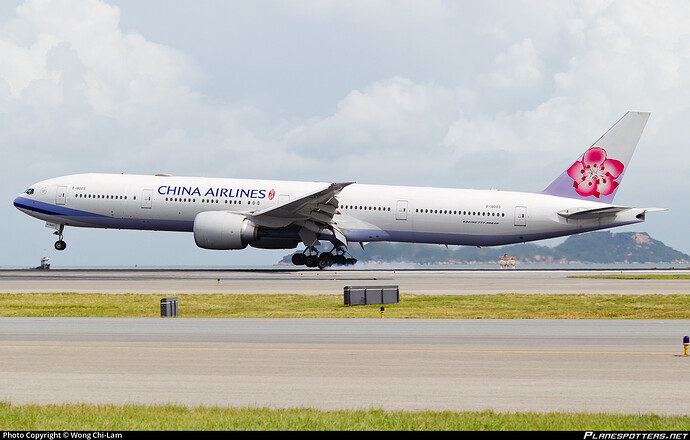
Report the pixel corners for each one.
[14,112,660,269]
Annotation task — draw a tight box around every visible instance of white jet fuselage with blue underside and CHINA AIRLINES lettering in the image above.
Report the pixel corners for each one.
[14,174,644,246]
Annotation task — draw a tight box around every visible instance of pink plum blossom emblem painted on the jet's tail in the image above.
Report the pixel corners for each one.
[568,147,624,198]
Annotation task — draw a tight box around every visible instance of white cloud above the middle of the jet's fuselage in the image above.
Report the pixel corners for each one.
[286,77,471,157]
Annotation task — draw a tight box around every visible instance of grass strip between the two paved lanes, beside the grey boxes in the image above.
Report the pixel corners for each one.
[0,293,690,319]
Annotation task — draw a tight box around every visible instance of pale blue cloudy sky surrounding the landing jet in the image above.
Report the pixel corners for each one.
[0,0,690,267]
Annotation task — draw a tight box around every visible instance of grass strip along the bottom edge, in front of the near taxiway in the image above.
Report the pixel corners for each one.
[0,403,690,431]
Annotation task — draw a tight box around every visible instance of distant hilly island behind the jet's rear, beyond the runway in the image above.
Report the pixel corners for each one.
[279,231,690,265]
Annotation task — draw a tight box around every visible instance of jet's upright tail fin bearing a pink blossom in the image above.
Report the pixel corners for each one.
[542,112,649,203]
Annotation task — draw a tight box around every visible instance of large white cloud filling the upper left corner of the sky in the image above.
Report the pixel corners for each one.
[0,0,201,125]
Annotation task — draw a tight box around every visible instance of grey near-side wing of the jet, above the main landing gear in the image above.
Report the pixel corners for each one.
[242,182,354,247]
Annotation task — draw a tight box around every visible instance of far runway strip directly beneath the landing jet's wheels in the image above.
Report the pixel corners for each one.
[0,269,690,295]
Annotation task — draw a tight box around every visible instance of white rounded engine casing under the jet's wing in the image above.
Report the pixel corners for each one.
[194,211,259,250]
